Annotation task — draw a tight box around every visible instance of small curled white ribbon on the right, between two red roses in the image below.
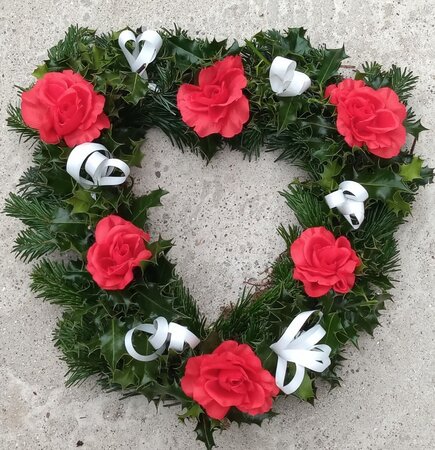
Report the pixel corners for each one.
[325,181,369,230]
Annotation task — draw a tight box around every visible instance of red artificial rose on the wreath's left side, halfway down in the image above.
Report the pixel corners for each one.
[86,215,152,291]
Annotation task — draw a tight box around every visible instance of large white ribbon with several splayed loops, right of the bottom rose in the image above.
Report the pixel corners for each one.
[270,311,331,395]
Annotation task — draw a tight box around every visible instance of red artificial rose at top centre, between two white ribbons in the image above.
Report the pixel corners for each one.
[177,56,249,138]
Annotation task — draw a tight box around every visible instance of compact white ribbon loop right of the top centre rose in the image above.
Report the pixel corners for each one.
[269,56,311,97]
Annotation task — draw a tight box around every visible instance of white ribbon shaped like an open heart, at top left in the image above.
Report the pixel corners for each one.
[118,30,163,80]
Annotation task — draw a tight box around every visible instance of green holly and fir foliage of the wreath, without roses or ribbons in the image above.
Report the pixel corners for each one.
[5,26,433,448]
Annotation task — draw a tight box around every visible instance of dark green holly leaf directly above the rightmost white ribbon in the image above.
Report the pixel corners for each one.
[355,168,412,201]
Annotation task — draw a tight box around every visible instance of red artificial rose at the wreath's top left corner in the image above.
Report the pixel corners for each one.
[21,70,110,147]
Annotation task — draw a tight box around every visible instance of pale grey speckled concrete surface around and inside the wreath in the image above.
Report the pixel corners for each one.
[0,0,435,450]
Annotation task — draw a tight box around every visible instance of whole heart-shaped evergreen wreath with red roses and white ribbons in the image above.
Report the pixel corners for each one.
[5,27,433,448]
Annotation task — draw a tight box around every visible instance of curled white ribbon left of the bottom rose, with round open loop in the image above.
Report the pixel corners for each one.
[124,317,200,362]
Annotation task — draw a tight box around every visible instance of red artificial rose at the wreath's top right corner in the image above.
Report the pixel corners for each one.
[325,79,406,158]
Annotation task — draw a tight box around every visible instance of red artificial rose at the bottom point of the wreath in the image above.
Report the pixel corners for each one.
[181,341,279,420]
